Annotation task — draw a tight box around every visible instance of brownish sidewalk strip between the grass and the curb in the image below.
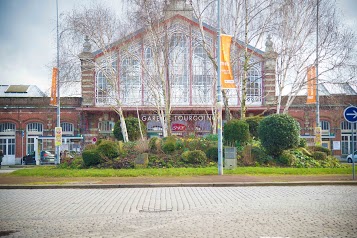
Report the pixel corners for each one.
[0,166,357,189]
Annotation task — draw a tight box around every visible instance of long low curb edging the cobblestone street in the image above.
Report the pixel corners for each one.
[0,181,357,189]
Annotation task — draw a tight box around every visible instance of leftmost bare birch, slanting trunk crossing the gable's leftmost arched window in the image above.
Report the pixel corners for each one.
[63,4,128,141]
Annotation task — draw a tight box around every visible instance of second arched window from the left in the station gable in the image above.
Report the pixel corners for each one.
[120,56,142,105]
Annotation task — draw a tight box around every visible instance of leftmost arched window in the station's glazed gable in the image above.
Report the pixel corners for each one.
[95,55,117,105]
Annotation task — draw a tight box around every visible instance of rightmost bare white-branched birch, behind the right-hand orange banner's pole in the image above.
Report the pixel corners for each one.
[273,0,356,113]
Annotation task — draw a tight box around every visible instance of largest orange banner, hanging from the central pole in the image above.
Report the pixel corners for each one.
[221,35,236,89]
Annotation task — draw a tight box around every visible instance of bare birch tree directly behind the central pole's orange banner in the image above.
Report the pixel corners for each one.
[193,0,274,120]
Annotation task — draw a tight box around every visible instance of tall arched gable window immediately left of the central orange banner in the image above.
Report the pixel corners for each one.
[192,45,213,105]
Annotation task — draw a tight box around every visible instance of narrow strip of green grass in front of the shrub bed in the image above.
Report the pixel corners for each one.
[1,166,352,177]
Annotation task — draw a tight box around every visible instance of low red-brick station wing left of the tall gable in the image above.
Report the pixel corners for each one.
[0,85,81,165]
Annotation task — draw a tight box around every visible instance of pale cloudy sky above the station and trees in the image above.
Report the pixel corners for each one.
[0,0,357,93]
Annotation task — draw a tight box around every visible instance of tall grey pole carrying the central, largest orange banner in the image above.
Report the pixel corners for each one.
[217,0,223,175]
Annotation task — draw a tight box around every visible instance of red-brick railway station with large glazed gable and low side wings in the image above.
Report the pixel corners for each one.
[0,1,357,165]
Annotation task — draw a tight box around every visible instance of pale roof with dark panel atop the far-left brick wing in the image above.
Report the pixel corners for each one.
[0,85,46,97]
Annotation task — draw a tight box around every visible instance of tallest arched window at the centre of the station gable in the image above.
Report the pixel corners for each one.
[169,33,190,105]
